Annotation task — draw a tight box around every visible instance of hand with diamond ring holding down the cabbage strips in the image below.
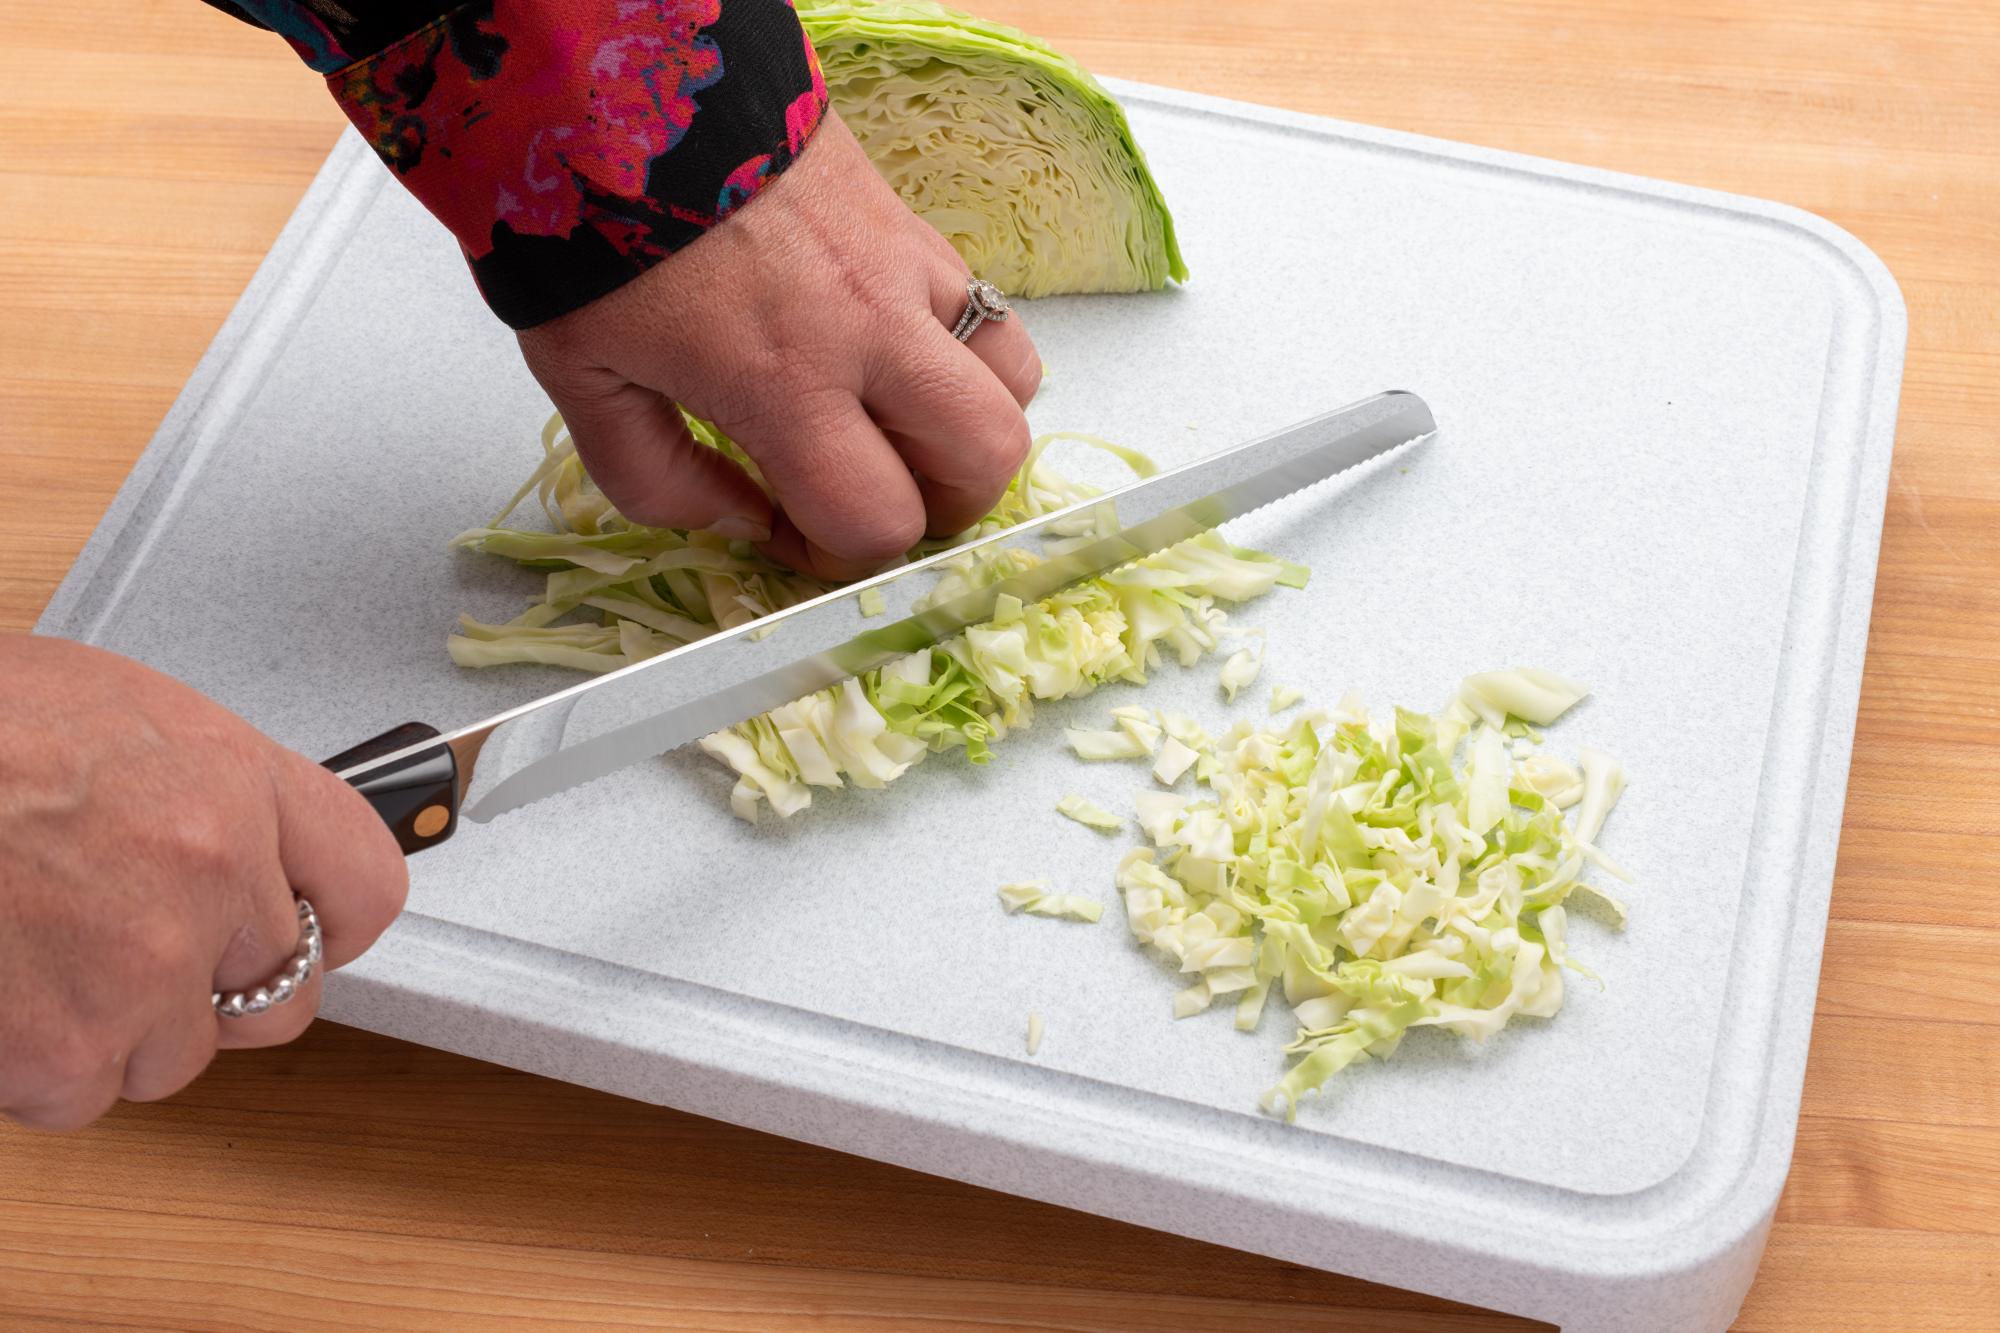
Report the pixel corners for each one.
[520,112,1042,578]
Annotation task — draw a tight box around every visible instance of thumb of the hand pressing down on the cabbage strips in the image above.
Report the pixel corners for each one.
[550,370,770,542]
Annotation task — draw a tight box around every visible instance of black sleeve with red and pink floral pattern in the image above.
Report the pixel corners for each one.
[208,0,826,328]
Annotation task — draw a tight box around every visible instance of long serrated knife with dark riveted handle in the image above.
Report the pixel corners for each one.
[326,390,1436,853]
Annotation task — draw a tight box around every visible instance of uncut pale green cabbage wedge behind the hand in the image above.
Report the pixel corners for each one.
[798,0,1188,296]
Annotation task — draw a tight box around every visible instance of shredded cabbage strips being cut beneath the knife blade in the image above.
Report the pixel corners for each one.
[448,416,1306,819]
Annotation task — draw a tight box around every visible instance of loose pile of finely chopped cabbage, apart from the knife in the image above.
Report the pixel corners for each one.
[1072,671,1630,1119]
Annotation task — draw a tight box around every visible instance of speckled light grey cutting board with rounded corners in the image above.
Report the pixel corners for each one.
[40,84,1904,1329]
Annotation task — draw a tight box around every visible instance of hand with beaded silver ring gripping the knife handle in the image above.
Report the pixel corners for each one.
[0,634,408,1129]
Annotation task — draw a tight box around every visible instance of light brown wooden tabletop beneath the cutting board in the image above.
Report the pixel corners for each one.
[0,0,2000,1331]
